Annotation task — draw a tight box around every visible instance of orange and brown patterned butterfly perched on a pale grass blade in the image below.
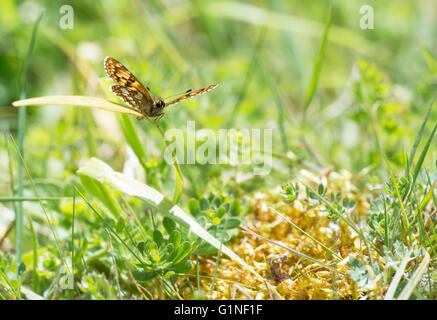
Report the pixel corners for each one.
[104,56,218,121]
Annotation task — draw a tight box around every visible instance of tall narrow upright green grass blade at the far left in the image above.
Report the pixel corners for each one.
[15,13,43,276]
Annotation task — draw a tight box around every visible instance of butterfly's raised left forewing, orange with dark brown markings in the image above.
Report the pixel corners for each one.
[104,56,153,104]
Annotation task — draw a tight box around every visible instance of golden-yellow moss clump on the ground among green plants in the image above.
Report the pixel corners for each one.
[179,171,380,299]
